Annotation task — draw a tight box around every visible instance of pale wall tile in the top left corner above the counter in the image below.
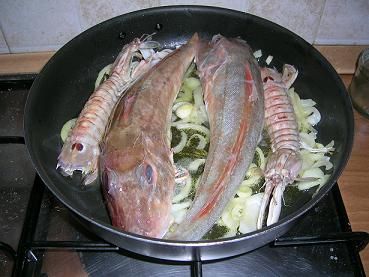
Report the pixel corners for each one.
[0,0,81,53]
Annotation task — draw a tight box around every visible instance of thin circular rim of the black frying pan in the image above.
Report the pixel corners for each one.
[24,5,354,248]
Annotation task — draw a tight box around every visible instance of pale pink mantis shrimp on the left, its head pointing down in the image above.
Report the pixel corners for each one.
[56,36,159,184]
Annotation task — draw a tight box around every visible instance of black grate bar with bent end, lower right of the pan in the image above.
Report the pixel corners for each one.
[272,232,369,252]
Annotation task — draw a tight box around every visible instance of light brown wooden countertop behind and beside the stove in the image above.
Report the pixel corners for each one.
[0,46,369,275]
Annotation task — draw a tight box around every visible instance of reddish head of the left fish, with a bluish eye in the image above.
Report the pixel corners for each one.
[101,136,174,238]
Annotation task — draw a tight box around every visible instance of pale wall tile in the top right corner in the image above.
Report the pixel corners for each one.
[315,0,369,45]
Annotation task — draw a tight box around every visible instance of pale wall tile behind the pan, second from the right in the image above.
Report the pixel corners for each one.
[246,0,325,43]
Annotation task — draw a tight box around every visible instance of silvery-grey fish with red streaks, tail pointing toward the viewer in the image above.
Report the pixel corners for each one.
[167,35,264,240]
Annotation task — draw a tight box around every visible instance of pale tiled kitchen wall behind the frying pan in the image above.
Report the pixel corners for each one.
[0,0,369,53]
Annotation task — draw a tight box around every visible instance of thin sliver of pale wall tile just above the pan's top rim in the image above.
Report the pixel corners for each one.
[160,0,247,11]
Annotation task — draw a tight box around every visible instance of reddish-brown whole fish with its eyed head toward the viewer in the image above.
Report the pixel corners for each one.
[100,34,198,238]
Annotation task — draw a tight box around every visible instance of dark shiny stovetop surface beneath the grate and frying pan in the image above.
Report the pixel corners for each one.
[0,75,364,276]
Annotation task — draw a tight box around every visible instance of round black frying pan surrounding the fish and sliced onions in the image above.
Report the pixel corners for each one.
[24,6,354,261]
